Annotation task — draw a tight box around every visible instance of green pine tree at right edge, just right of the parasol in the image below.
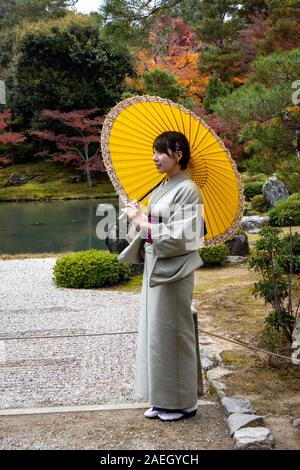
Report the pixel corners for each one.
[213,48,300,184]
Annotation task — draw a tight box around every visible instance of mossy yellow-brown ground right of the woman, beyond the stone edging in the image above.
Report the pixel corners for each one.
[194,264,300,450]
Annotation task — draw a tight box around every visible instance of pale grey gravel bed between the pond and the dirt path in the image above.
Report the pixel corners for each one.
[0,258,140,409]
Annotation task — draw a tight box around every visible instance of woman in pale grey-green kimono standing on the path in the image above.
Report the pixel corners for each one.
[119,132,203,421]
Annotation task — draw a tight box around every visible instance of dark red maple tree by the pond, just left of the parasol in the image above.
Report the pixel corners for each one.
[30,108,105,186]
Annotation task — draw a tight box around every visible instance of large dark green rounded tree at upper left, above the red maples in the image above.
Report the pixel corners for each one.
[7,13,132,125]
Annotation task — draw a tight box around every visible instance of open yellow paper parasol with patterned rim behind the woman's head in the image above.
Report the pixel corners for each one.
[101,96,244,246]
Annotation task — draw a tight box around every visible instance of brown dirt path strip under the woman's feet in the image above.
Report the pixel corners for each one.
[0,404,233,450]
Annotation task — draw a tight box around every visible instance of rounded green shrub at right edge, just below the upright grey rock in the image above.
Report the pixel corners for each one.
[268,194,300,227]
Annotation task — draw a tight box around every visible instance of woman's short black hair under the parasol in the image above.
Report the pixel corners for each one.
[153,131,191,170]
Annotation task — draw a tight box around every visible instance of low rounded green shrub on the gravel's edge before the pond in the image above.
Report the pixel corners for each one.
[53,250,131,289]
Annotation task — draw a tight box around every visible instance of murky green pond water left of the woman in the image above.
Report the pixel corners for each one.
[0,199,118,254]
